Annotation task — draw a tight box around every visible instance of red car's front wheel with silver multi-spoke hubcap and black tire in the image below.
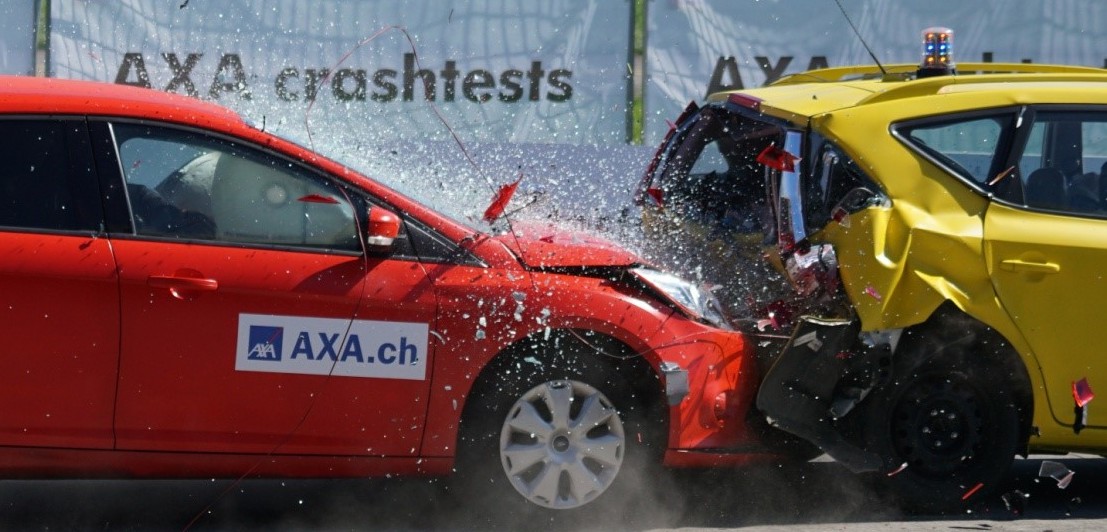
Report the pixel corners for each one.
[452,335,664,513]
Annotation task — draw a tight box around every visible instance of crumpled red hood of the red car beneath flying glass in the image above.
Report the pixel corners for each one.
[494,223,642,268]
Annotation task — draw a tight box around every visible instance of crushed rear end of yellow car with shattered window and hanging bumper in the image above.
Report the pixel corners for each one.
[639,95,898,471]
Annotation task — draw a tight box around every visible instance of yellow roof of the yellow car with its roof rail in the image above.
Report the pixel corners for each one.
[707,63,1107,123]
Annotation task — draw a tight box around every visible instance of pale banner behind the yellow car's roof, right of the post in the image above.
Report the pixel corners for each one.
[645,0,1107,145]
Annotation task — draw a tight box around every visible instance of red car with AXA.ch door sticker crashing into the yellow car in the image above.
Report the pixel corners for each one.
[0,77,770,509]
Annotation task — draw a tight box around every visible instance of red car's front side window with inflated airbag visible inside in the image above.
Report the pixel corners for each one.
[113,124,361,251]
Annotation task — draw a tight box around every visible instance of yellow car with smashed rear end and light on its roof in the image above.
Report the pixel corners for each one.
[639,30,1107,511]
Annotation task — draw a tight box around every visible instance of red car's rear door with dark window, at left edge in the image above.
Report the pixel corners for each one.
[0,118,120,449]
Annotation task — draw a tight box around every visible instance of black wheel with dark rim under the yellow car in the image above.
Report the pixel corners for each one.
[857,338,1022,513]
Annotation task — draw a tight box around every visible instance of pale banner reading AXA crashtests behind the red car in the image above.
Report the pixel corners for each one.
[50,0,631,145]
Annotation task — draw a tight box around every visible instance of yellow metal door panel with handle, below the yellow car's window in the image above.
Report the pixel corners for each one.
[984,204,1107,428]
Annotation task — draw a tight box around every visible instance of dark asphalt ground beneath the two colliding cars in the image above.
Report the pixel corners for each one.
[0,455,1107,531]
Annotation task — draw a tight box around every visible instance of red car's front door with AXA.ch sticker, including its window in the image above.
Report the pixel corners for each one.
[96,124,435,456]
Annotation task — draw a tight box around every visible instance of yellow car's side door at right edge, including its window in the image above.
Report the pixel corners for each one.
[984,106,1107,429]
